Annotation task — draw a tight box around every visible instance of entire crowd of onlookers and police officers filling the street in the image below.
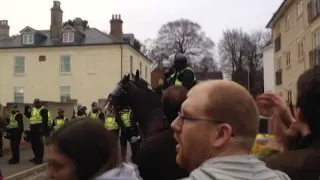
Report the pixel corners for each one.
[1,54,320,180]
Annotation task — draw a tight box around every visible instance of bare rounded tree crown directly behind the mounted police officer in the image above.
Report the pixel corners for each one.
[148,19,215,66]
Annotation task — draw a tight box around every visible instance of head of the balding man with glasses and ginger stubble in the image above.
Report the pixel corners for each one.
[171,80,259,171]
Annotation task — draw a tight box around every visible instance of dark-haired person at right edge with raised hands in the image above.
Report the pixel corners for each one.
[258,66,320,180]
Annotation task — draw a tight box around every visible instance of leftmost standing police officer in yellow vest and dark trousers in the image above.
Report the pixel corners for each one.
[7,105,24,164]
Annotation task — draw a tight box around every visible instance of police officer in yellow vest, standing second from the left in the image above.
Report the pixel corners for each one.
[25,99,48,164]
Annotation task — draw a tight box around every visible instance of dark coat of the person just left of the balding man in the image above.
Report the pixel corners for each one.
[135,127,189,180]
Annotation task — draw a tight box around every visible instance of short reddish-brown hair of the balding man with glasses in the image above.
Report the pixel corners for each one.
[204,80,259,151]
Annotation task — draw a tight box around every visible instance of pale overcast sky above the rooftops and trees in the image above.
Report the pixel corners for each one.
[0,0,283,42]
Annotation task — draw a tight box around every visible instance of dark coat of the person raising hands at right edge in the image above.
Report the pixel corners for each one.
[266,135,320,180]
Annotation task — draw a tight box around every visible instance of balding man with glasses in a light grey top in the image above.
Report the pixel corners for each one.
[171,80,289,180]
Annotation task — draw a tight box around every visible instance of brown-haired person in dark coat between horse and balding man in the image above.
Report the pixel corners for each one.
[135,86,189,180]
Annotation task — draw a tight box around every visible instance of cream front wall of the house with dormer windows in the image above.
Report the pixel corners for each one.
[0,45,121,109]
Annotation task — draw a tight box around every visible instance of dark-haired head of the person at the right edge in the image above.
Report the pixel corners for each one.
[295,66,320,138]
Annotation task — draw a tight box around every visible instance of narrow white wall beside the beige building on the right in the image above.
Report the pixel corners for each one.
[263,44,275,92]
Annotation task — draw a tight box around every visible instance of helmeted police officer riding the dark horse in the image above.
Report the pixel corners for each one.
[163,53,196,90]
